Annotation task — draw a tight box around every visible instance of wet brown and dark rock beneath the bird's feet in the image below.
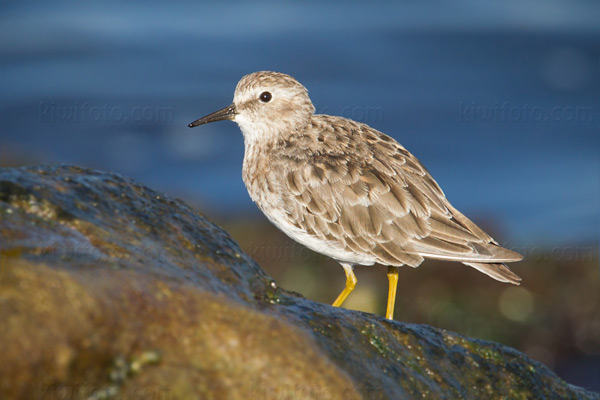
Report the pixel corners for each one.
[0,166,600,399]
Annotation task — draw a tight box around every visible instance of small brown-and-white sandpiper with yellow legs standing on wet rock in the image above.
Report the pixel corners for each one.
[188,71,523,320]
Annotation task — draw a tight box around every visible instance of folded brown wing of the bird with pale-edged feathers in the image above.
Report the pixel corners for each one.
[284,120,522,267]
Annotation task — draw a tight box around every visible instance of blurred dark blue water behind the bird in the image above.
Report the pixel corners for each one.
[0,0,600,247]
